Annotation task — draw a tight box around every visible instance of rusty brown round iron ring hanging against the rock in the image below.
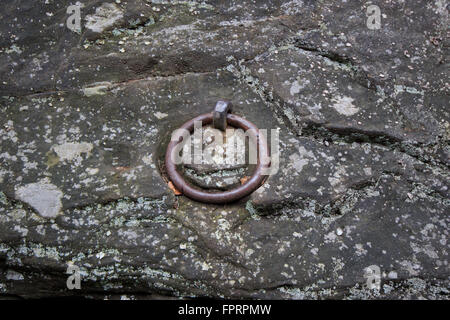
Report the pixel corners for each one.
[165,113,270,204]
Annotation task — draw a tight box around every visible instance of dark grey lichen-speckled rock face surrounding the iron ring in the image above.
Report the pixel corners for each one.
[0,0,450,299]
